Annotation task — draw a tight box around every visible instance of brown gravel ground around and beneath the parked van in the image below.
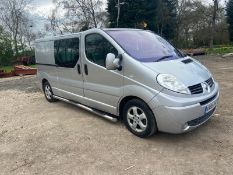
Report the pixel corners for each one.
[0,57,233,175]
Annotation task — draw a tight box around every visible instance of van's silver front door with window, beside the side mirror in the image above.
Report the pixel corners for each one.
[82,33,123,114]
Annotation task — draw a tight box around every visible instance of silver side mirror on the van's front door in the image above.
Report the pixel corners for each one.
[106,53,121,70]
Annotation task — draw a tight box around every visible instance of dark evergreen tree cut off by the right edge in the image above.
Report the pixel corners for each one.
[226,0,233,42]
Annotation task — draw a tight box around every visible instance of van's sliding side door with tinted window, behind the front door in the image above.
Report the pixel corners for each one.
[54,35,83,102]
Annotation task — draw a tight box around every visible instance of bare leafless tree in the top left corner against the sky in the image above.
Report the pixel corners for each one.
[0,0,29,55]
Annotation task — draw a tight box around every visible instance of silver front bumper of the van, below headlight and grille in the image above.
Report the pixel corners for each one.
[150,83,219,134]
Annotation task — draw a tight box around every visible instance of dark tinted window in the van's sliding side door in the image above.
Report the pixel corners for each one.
[54,38,79,68]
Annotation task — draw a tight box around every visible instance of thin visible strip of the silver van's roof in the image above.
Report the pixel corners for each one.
[35,28,142,42]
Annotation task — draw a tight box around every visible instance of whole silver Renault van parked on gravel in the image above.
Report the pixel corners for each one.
[35,29,219,137]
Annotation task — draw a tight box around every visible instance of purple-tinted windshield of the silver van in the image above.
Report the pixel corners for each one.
[106,30,184,62]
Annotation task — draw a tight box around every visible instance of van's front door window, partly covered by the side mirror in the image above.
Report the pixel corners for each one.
[85,34,118,67]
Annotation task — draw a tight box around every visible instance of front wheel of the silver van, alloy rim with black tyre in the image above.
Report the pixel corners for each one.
[123,99,157,138]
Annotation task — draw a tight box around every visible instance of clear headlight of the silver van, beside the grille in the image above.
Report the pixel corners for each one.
[157,74,191,94]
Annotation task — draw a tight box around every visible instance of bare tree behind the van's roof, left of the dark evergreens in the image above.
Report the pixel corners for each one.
[49,0,106,34]
